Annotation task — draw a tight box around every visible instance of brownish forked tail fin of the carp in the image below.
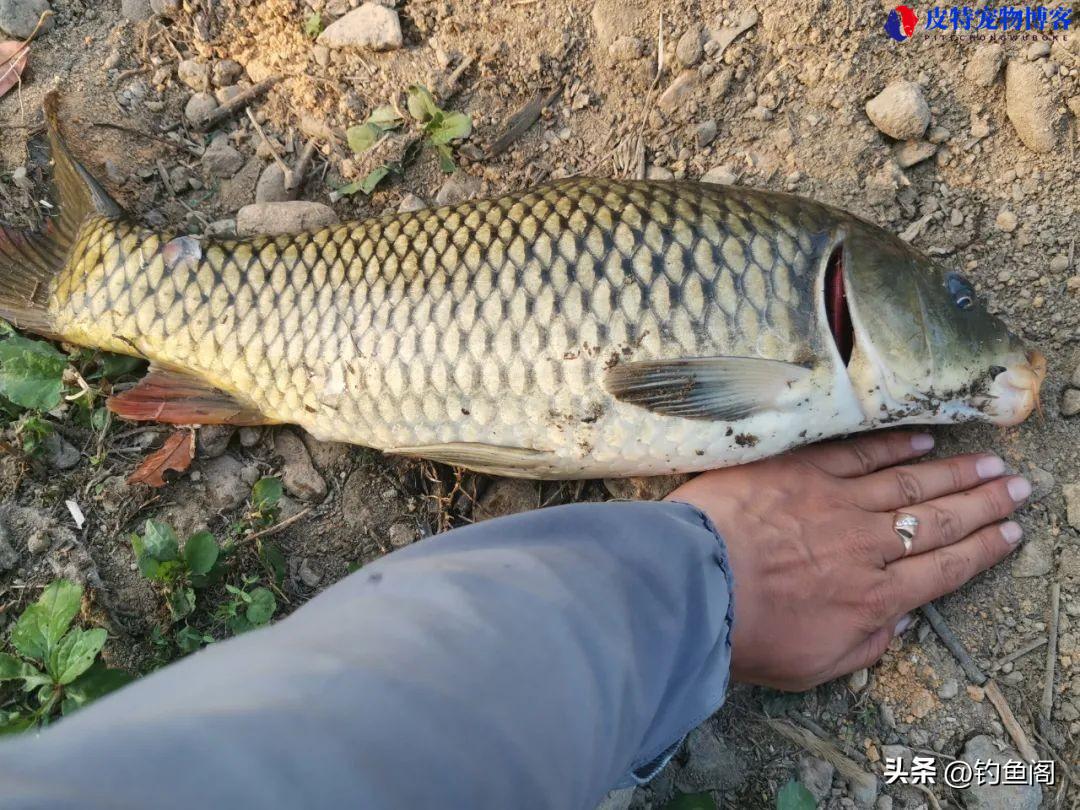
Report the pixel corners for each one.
[0,91,123,335]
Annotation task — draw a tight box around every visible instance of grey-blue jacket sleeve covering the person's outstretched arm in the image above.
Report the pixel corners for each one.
[0,503,732,810]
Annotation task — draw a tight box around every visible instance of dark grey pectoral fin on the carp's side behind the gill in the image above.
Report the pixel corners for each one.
[605,357,810,421]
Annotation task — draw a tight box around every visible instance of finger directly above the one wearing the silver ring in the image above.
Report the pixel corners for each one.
[852,455,1005,512]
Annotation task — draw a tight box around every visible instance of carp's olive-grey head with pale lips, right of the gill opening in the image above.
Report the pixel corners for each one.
[839,224,1047,424]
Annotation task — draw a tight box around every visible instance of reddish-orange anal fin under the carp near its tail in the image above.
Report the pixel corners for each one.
[106,366,273,426]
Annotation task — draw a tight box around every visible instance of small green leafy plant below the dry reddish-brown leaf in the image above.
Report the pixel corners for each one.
[132,521,221,622]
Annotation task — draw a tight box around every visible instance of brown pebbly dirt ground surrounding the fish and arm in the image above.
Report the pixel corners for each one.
[0,0,1080,810]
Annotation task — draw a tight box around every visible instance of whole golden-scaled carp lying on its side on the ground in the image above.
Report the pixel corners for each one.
[0,95,1045,478]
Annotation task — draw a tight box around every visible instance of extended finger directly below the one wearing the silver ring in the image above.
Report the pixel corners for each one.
[886,521,1024,610]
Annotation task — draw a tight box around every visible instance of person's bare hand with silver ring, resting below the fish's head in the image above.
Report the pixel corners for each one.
[667,432,1031,690]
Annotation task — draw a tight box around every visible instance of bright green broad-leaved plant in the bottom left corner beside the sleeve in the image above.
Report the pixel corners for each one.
[0,580,132,734]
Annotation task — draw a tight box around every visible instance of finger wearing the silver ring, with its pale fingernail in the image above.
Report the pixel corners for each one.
[881,475,1031,562]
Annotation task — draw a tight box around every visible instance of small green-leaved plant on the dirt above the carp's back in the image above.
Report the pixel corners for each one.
[338,84,472,194]
